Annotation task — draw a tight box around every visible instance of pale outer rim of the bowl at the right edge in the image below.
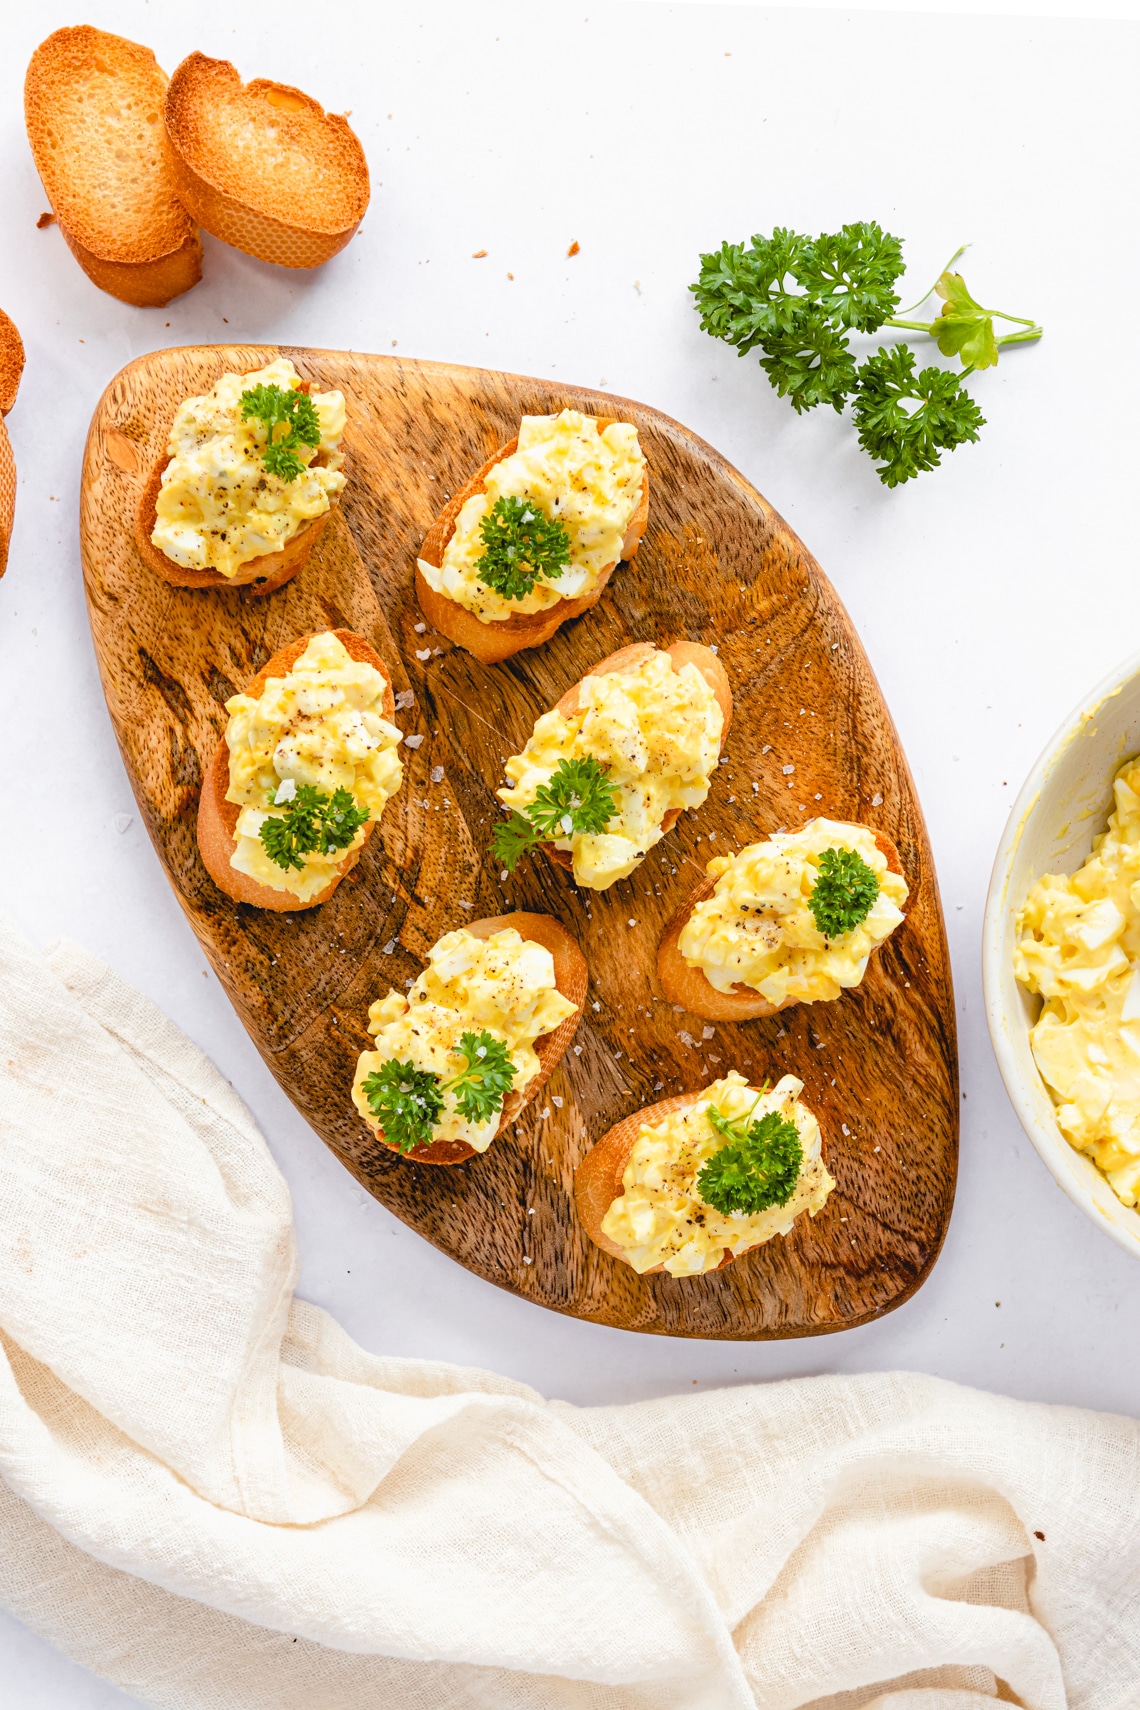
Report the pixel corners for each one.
[981,653,1140,1259]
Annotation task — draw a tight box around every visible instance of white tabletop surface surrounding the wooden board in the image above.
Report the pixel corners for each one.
[0,0,1140,1710]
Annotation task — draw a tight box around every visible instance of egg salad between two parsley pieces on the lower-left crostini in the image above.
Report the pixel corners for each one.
[352,927,578,1153]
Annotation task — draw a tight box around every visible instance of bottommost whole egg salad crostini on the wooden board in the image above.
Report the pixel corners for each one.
[574,1069,836,1277]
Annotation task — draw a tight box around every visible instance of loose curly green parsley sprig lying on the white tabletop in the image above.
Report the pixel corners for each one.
[690,221,1041,487]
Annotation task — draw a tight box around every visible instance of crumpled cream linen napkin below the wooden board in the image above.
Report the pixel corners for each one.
[0,923,1140,1710]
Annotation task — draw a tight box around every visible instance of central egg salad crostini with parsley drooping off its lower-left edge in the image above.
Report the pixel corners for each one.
[492,641,732,891]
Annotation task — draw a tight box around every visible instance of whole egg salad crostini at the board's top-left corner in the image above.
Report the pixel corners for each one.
[135,357,345,593]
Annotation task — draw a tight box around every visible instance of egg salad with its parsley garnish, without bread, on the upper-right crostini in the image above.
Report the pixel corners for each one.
[419,409,644,624]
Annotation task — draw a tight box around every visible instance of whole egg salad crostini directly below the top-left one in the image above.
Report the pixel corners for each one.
[198,629,403,913]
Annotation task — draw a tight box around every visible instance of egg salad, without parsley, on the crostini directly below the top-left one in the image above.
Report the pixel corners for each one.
[226,633,403,901]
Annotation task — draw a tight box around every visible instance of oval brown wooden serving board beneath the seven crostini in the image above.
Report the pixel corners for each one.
[80,345,959,1339]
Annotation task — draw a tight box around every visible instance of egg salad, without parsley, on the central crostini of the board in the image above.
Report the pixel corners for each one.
[499,652,725,891]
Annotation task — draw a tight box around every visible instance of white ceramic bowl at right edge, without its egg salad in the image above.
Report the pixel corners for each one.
[981,655,1140,1259]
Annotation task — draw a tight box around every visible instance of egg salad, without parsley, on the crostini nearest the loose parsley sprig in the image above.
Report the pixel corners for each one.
[419,410,644,624]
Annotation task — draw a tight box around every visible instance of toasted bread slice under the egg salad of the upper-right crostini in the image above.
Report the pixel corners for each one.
[415,416,649,665]
